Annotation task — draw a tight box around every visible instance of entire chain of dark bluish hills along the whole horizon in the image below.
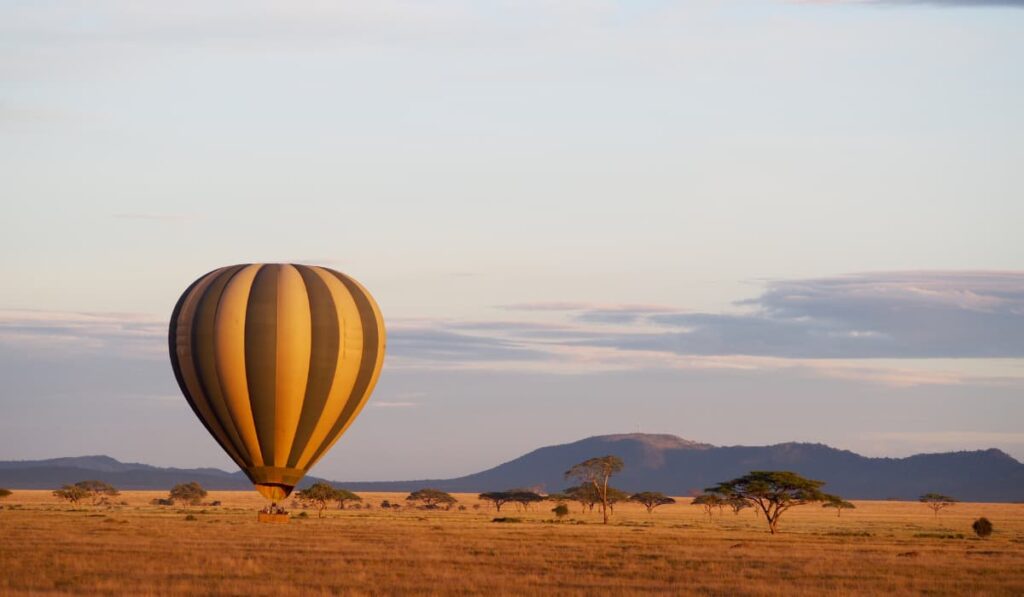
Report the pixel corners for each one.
[6,433,1024,502]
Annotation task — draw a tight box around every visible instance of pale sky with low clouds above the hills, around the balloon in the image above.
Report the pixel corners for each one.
[0,0,1024,480]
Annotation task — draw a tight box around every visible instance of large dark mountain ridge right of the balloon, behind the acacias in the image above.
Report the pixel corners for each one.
[337,433,1024,502]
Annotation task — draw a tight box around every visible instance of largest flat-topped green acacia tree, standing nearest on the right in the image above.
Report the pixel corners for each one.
[707,471,828,535]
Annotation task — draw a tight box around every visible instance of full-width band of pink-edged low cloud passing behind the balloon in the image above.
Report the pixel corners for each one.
[0,271,1024,385]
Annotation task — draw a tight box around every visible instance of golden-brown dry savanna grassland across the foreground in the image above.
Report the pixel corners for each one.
[0,491,1024,596]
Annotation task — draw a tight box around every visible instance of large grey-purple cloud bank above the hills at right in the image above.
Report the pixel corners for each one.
[598,271,1024,358]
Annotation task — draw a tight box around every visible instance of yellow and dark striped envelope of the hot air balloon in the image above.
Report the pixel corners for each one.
[169,263,384,500]
